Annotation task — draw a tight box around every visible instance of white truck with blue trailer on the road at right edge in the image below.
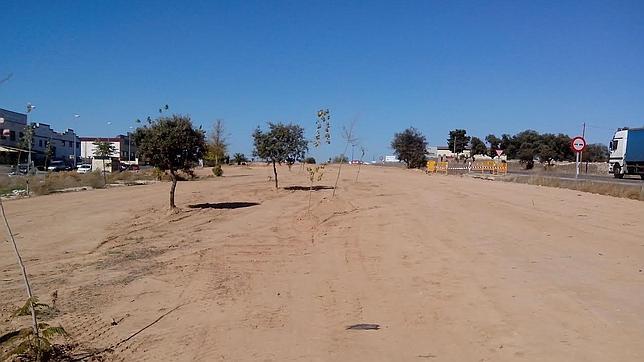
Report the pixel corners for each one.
[608,128,644,180]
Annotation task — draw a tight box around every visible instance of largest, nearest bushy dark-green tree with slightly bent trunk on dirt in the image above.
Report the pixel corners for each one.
[134,114,206,209]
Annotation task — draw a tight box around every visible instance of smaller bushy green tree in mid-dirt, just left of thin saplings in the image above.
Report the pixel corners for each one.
[253,122,309,189]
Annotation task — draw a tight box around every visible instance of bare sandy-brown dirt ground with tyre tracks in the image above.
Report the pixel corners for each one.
[0,166,644,361]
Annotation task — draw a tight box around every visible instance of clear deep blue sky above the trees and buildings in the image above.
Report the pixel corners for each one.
[0,0,644,159]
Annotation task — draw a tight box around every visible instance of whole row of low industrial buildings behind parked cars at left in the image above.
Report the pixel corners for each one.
[0,108,138,165]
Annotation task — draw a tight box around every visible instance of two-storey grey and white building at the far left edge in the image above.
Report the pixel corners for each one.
[0,109,80,164]
